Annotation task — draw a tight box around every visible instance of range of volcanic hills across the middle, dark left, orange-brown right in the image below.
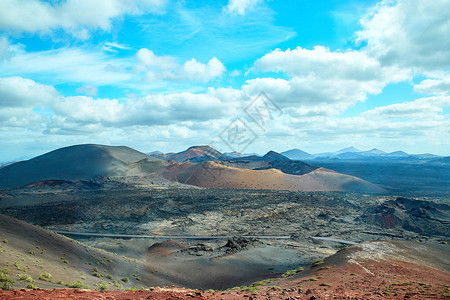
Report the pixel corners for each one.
[0,144,383,193]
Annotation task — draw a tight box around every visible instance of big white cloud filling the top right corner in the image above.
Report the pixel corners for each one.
[357,0,450,73]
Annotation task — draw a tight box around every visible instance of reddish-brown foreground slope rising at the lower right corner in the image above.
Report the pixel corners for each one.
[0,241,450,299]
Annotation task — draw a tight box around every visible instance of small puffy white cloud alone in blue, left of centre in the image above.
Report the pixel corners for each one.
[134,48,225,82]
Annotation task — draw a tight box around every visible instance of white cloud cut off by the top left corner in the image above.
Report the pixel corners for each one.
[0,0,165,39]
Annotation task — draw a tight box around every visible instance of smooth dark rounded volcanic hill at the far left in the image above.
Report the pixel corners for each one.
[0,144,152,188]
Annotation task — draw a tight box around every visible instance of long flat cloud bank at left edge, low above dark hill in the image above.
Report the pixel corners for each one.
[0,77,242,133]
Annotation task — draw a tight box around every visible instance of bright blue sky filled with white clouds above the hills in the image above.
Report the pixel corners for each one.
[0,0,450,161]
